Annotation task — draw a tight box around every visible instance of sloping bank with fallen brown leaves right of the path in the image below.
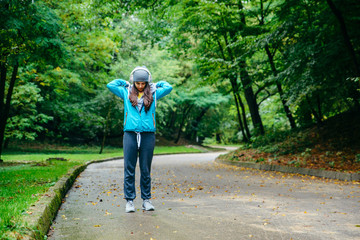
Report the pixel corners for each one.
[221,110,360,173]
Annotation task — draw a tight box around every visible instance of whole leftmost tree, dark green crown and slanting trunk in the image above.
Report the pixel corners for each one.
[0,0,62,160]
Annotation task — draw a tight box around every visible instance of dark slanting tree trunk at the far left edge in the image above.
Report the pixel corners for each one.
[0,63,19,159]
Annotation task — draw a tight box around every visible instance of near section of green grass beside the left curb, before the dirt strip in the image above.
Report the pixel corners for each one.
[0,161,79,239]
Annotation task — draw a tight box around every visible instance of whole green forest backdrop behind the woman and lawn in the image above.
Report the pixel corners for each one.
[0,0,360,165]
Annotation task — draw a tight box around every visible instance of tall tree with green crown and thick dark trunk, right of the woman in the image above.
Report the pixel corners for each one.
[169,1,264,139]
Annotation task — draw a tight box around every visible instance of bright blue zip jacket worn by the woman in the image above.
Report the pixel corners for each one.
[107,79,172,132]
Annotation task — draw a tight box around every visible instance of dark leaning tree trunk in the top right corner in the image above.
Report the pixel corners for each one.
[326,0,360,76]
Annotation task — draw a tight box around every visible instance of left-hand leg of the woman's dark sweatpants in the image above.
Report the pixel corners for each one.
[123,132,138,200]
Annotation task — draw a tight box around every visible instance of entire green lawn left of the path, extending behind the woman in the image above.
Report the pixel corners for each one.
[0,146,201,239]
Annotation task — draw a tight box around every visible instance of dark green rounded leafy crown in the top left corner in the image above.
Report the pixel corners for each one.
[0,1,62,65]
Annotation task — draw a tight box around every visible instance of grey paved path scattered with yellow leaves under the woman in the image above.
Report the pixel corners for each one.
[49,153,360,240]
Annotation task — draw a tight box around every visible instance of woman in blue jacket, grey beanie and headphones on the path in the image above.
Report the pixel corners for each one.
[107,66,172,212]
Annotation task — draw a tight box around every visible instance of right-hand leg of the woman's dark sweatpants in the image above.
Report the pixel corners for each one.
[139,132,155,200]
